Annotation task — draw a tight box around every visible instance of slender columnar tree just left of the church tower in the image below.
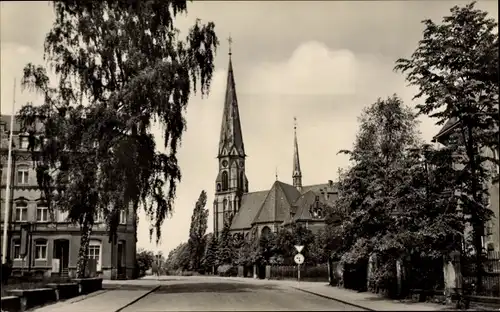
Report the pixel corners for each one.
[188,191,208,271]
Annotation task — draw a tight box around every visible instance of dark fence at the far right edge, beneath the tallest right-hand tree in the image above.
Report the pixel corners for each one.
[461,251,500,297]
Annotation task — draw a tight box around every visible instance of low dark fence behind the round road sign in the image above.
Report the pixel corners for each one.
[270,264,328,283]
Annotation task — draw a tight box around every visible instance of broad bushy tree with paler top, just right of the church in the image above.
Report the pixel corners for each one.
[326,96,461,294]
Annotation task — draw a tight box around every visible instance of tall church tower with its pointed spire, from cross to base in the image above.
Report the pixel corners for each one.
[214,38,248,236]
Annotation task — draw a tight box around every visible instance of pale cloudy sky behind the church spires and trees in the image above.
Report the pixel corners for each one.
[0,0,498,253]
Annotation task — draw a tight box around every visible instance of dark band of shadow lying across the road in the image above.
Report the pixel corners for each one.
[155,283,277,294]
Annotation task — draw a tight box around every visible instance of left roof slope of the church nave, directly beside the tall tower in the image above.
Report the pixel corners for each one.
[231,191,269,230]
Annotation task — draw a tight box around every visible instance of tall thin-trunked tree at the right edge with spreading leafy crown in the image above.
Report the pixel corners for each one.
[395,2,499,289]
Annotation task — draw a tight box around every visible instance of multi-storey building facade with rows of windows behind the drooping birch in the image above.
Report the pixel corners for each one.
[0,115,136,279]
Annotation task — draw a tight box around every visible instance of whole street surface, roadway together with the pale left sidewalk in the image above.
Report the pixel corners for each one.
[36,276,362,312]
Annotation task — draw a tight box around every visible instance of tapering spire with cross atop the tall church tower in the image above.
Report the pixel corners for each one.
[218,36,245,157]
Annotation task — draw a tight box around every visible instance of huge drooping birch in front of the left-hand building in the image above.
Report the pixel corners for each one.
[19,0,218,277]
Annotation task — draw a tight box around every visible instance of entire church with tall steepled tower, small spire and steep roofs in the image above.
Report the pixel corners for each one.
[213,51,338,238]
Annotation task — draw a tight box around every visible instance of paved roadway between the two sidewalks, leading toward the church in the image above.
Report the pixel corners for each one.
[114,277,360,312]
